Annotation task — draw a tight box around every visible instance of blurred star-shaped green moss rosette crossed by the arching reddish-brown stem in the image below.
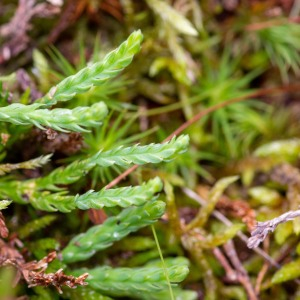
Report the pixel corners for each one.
[194,49,264,159]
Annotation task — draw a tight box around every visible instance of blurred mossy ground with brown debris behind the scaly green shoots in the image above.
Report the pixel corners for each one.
[0,0,300,299]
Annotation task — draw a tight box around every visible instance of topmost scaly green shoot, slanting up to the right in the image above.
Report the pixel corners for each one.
[40,30,143,105]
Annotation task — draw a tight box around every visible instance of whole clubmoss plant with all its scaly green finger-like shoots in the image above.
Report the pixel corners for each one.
[0,31,195,299]
